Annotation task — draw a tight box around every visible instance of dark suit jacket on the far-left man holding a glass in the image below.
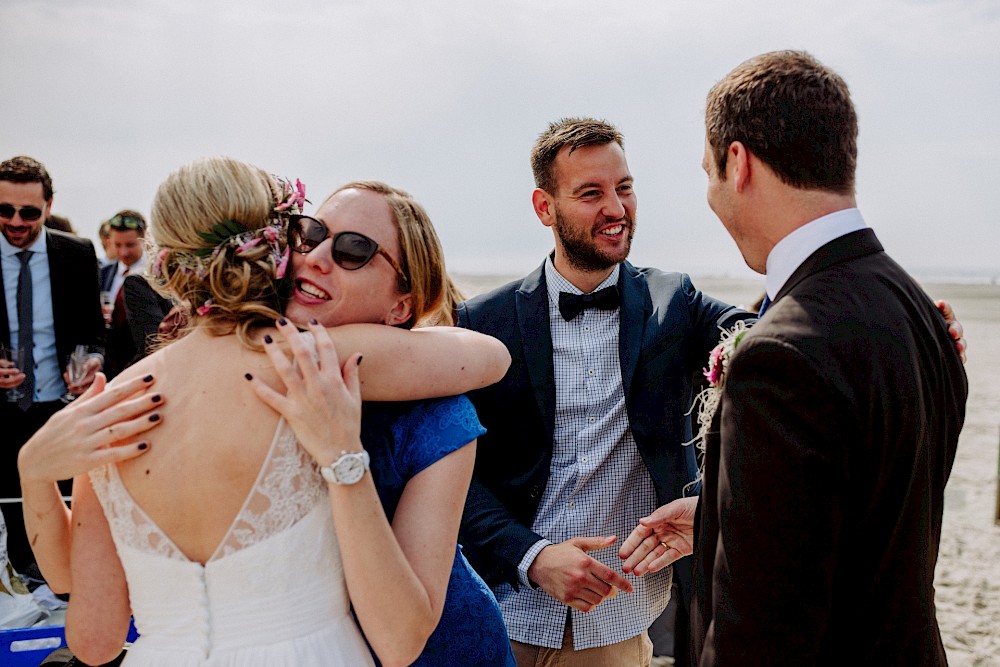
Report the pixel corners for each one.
[0,229,104,396]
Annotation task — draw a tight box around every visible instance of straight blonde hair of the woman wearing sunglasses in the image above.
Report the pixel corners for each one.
[327,181,463,329]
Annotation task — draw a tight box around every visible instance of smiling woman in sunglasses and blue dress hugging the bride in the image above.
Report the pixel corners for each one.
[258,181,514,667]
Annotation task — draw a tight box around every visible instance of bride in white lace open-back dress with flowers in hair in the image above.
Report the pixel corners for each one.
[19,158,509,667]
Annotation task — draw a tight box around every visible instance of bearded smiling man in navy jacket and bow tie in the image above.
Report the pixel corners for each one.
[458,119,749,667]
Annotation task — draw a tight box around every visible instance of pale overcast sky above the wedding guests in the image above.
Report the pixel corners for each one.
[0,0,1000,278]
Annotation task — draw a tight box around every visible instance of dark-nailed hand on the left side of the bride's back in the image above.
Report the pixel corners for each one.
[17,373,164,484]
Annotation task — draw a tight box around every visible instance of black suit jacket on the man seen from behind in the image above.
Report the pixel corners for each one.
[692,229,967,666]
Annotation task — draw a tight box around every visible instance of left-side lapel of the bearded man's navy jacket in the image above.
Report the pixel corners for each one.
[514,264,556,442]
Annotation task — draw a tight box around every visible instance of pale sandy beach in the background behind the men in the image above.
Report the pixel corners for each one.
[455,275,1000,667]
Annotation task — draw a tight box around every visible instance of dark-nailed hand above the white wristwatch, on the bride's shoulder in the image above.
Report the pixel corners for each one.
[244,318,361,465]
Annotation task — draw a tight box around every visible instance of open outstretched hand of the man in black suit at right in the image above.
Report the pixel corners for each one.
[618,497,698,577]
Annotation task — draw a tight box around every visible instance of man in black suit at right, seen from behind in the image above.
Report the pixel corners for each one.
[692,51,968,665]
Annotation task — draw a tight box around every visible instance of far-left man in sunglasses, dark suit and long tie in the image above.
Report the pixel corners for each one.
[0,156,104,572]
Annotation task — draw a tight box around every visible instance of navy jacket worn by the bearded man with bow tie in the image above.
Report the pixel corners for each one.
[458,262,749,588]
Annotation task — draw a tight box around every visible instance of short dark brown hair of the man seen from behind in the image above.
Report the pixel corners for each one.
[705,51,858,194]
